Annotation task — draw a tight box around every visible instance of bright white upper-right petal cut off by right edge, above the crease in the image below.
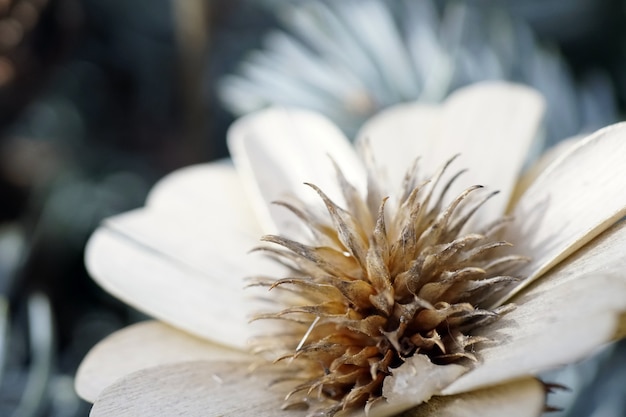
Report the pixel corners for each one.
[504,124,626,297]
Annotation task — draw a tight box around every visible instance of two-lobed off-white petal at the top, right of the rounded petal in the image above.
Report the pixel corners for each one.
[359,82,544,224]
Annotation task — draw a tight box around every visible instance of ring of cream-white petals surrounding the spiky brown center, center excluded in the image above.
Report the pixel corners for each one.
[77,83,626,416]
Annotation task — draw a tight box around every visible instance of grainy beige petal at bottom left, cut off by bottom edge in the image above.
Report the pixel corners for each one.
[90,361,294,417]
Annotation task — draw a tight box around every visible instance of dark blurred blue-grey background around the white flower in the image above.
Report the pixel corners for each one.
[0,0,626,417]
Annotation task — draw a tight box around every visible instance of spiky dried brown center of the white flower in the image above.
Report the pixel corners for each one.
[249,158,527,415]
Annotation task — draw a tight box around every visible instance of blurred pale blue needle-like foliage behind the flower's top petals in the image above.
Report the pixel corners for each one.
[218,0,617,143]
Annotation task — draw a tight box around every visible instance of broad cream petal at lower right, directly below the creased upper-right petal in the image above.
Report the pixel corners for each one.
[444,219,626,394]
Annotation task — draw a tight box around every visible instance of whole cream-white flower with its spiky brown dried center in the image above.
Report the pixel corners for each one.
[76,83,626,417]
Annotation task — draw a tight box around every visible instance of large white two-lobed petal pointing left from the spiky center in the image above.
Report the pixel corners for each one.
[85,162,278,347]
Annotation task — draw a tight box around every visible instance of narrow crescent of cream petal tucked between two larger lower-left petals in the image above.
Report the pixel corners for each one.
[75,321,246,402]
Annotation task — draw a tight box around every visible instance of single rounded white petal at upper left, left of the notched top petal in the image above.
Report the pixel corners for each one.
[228,108,366,237]
